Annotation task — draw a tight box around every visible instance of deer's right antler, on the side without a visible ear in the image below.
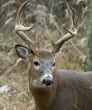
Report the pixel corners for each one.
[52,2,77,52]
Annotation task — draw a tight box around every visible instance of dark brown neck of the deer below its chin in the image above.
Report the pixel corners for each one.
[30,70,57,110]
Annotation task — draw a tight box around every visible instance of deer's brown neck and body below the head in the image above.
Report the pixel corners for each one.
[29,62,92,110]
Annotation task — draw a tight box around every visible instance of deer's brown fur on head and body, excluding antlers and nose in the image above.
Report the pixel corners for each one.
[16,45,92,110]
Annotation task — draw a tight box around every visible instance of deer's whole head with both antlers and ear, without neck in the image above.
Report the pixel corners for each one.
[15,0,77,87]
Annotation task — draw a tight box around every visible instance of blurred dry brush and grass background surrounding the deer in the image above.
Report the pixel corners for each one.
[0,0,92,110]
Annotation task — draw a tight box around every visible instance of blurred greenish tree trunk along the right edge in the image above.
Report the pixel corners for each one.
[86,0,92,71]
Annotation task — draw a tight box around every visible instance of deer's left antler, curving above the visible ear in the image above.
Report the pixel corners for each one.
[15,0,37,47]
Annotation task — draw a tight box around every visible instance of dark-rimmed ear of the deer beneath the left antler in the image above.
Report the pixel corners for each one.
[15,44,29,59]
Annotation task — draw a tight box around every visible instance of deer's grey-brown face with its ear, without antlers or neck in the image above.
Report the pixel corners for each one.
[15,45,55,86]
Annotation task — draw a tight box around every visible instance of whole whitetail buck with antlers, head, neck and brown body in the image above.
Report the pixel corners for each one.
[15,1,92,110]
